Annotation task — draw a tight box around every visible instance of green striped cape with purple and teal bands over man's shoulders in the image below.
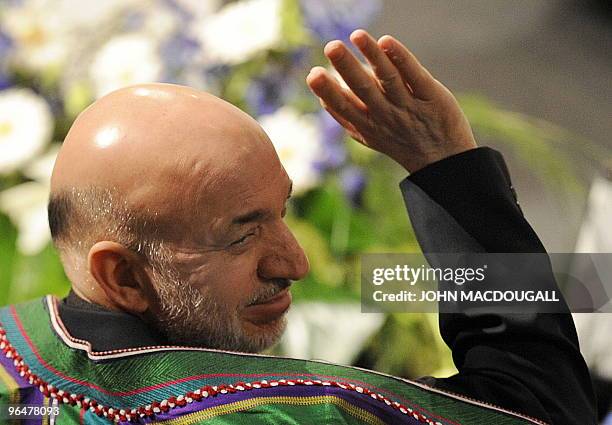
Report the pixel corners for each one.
[0,296,541,425]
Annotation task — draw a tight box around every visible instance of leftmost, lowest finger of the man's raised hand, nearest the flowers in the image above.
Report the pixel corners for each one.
[306,66,364,126]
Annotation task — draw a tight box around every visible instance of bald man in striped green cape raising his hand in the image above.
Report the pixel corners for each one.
[0,30,594,424]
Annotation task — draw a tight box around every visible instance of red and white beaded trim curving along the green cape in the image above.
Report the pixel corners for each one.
[0,326,443,425]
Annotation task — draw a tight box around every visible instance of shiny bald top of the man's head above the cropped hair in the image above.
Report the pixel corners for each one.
[51,84,270,222]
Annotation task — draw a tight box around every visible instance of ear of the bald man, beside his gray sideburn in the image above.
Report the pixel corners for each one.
[87,241,151,316]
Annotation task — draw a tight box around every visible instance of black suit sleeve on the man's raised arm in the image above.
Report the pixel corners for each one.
[400,147,596,425]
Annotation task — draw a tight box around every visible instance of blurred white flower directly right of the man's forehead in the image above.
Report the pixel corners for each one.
[259,107,323,194]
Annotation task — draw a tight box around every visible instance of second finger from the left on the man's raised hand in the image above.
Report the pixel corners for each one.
[323,40,384,106]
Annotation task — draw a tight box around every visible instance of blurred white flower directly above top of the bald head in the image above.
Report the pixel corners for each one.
[89,34,162,97]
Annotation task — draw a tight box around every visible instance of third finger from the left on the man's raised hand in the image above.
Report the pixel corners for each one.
[351,30,411,106]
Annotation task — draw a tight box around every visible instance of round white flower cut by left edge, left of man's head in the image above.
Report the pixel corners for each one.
[0,89,53,174]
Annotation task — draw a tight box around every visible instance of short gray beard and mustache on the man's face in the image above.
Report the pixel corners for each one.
[148,273,286,353]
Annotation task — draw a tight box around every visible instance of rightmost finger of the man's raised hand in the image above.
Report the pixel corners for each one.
[378,35,437,100]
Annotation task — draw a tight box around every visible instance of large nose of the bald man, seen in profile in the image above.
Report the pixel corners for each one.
[258,223,310,280]
